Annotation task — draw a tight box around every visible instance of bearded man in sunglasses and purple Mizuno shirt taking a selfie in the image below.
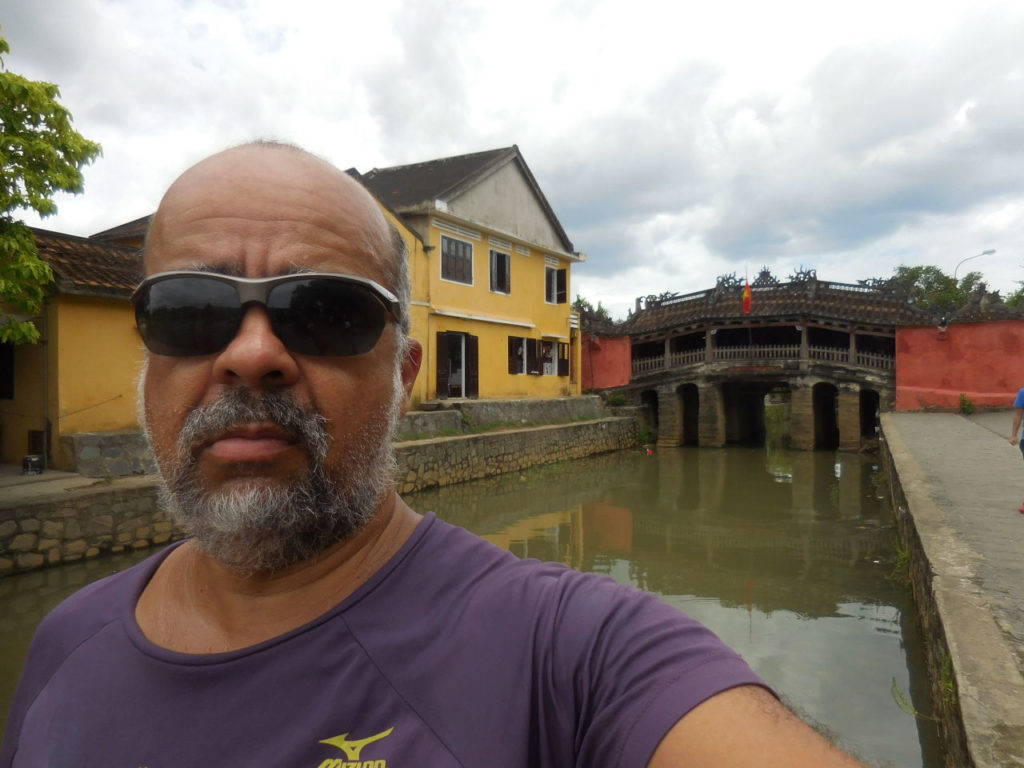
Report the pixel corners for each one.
[0,144,860,768]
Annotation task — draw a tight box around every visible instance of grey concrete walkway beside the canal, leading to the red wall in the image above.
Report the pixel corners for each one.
[882,410,1024,768]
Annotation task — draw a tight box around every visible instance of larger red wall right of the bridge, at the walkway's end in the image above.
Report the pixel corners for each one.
[896,319,1024,411]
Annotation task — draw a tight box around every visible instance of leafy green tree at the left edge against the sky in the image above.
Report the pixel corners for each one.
[0,30,100,344]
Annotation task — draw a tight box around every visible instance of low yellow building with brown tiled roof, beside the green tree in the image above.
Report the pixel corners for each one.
[0,229,142,469]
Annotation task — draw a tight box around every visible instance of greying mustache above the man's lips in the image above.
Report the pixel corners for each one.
[178,388,331,461]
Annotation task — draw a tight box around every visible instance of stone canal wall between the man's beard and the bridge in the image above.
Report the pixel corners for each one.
[395,417,636,494]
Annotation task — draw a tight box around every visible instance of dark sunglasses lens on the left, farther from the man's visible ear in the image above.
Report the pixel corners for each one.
[135,275,242,357]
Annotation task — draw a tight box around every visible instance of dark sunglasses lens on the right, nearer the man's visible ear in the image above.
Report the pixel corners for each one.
[266,278,388,356]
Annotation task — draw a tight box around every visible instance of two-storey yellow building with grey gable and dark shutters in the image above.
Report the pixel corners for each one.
[357,145,584,403]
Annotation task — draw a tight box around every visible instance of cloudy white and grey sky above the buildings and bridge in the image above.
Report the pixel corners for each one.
[0,0,1024,317]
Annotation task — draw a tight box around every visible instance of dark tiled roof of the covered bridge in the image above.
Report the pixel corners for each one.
[624,279,933,336]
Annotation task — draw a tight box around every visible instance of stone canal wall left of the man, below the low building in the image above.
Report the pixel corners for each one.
[0,476,182,575]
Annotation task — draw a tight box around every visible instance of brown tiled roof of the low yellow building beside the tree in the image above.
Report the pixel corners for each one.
[32,227,142,299]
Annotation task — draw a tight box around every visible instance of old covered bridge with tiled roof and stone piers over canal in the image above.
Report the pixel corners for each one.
[624,269,932,451]
